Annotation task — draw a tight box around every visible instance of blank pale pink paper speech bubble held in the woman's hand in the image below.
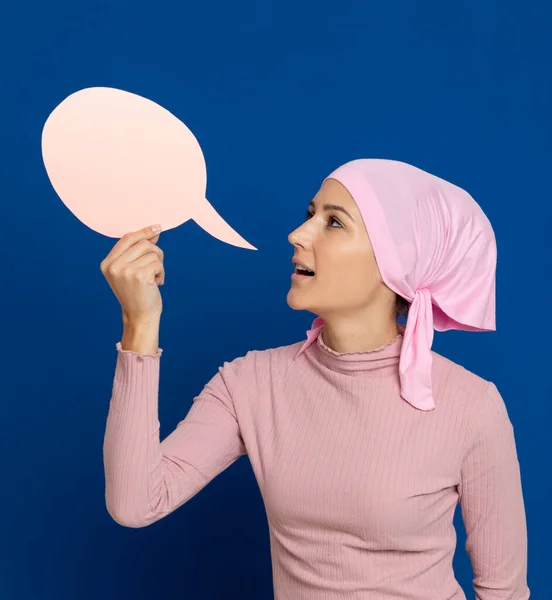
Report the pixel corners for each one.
[42,87,257,250]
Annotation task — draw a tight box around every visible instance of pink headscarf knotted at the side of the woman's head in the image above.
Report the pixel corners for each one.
[300,158,496,410]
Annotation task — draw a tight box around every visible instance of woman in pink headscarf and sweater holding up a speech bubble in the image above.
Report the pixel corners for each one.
[102,159,529,600]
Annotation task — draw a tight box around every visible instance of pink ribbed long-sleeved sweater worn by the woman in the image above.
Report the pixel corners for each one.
[104,334,529,600]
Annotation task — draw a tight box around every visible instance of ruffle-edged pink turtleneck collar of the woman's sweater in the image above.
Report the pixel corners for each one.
[306,324,405,377]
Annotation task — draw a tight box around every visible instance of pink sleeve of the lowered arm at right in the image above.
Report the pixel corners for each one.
[459,382,530,600]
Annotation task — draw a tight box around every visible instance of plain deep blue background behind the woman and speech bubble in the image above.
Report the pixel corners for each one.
[0,0,552,600]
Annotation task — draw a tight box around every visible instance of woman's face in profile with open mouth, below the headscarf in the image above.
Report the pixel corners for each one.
[287,179,388,319]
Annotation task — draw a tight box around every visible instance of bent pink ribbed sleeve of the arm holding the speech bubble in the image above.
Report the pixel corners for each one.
[103,342,246,527]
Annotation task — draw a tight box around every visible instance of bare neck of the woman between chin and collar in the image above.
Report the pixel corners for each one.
[322,317,399,353]
